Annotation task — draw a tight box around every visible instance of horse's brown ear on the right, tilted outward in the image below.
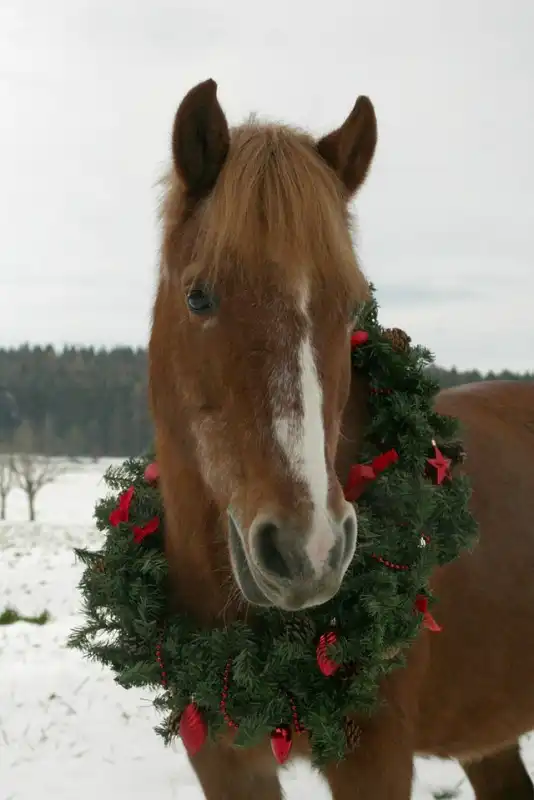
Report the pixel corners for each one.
[317,96,378,197]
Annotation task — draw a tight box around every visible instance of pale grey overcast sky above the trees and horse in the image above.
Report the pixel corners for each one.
[0,0,534,370]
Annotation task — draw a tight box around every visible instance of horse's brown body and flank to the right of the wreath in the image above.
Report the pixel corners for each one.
[324,381,534,800]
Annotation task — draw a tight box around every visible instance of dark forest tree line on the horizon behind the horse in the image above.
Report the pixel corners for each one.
[0,346,534,458]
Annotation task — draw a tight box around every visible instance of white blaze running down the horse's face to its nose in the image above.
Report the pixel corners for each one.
[272,290,335,575]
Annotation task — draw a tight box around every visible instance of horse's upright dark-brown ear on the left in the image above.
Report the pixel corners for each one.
[172,79,230,199]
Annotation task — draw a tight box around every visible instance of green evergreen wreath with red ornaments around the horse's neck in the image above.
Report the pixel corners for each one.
[69,290,477,765]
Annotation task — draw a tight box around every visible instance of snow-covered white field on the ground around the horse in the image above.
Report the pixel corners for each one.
[0,461,534,800]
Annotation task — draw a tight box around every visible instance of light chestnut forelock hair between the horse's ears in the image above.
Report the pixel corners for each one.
[162,115,367,295]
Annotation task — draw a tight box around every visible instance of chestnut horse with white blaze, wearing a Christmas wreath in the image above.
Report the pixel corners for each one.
[149,80,534,800]
